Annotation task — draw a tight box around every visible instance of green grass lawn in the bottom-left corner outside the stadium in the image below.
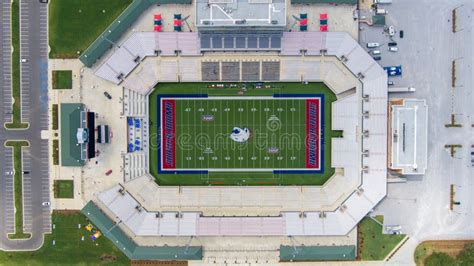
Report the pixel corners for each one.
[0,211,130,265]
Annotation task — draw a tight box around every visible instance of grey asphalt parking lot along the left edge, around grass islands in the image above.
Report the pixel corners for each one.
[0,0,51,250]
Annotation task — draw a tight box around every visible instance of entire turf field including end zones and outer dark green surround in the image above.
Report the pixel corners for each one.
[149,83,341,186]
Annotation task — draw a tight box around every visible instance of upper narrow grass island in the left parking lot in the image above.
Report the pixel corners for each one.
[5,0,28,129]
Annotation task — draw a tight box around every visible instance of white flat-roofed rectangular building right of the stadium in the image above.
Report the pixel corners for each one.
[388,99,428,175]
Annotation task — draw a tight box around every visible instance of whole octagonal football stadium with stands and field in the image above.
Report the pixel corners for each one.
[53,0,388,265]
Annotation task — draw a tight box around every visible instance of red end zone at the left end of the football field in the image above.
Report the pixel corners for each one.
[161,100,176,169]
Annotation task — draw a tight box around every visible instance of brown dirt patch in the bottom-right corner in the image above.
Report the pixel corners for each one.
[415,240,474,265]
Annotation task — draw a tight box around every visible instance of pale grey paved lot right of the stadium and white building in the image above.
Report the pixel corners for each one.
[361,0,474,265]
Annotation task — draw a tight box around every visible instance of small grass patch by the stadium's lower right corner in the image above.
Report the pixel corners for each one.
[358,216,405,260]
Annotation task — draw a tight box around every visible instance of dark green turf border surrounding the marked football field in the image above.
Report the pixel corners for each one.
[149,83,341,186]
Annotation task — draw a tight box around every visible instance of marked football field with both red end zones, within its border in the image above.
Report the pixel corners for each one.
[159,95,322,173]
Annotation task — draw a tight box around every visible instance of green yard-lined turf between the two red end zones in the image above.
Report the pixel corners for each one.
[168,97,312,171]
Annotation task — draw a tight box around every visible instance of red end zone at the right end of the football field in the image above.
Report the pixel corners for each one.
[306,99,321,169]
